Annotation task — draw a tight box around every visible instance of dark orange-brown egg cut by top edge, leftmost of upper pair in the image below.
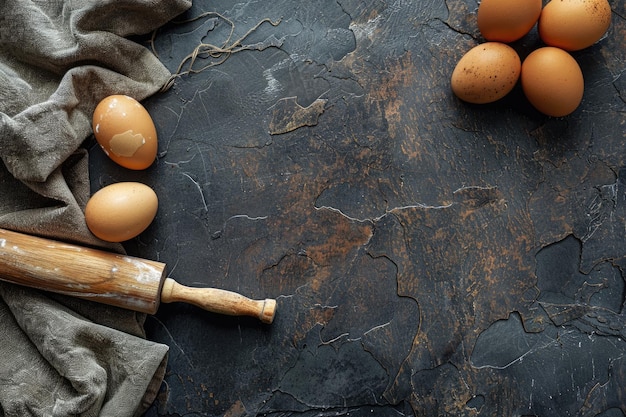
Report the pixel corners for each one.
[477,0,541,42]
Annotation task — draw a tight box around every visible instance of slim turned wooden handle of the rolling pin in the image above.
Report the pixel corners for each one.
[161,278,276,324]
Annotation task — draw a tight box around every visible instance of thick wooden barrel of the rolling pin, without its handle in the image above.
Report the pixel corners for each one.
[0,229,165,314]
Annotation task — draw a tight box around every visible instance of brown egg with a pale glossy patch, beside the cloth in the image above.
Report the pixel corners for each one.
[92,95,158,170]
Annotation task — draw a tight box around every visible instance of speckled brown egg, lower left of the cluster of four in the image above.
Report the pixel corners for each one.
[451,42,521,104]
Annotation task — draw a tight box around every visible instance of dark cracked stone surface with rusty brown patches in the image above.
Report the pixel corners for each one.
[91,0,626,417]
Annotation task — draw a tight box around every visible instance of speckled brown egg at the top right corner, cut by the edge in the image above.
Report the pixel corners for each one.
[538,0,611,51]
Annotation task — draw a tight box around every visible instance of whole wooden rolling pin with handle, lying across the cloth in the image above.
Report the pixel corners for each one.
[0,229,276,323]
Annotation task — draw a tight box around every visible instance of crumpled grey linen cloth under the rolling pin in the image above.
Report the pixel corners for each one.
[0,0,191,417]
